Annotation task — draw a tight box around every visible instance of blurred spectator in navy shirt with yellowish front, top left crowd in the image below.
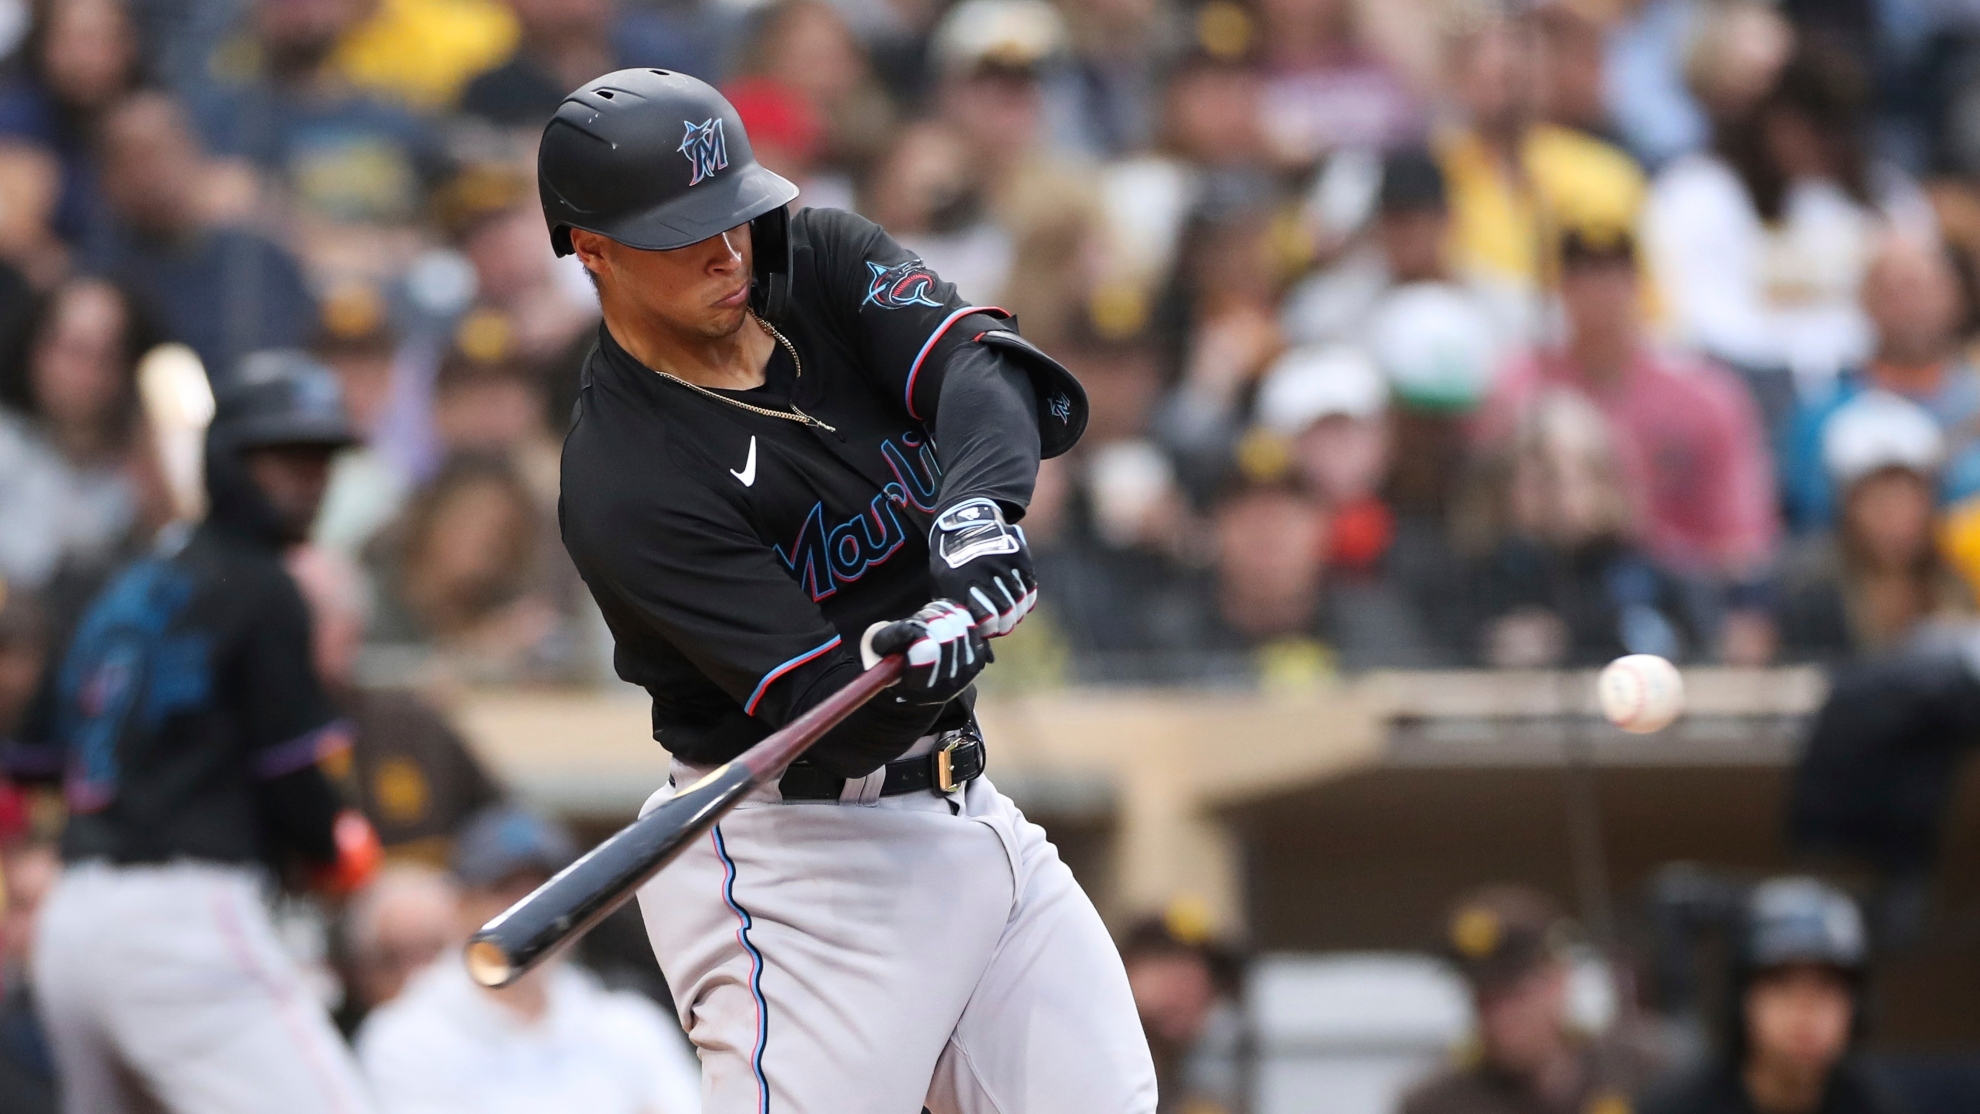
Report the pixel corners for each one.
[192,0,438,286]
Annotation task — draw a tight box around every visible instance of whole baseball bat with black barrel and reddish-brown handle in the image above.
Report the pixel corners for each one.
[467,655,903,987]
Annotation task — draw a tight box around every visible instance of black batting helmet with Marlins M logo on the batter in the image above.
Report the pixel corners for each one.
[537,69,798,315]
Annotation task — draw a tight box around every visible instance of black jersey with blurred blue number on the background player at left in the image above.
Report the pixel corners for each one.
[8,524,347,863]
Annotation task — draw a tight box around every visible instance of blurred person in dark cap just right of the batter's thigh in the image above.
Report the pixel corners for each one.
[1121,900,1241,1114]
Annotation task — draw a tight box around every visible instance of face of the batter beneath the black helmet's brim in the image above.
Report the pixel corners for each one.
[570,224,754,340]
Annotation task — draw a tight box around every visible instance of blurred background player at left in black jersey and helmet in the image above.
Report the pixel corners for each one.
[10,352,376,1114]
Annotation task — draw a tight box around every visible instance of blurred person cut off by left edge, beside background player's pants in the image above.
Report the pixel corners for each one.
[0,811,61,1114]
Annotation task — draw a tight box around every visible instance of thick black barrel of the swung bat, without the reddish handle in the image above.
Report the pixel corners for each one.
[467,762,756,987]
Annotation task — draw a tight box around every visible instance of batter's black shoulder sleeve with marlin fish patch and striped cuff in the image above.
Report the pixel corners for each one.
[796,210,1010,421]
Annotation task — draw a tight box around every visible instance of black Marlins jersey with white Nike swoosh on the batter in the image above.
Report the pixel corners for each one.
[560,210,1085,776]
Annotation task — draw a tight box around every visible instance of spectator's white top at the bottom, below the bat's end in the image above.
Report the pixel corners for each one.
[356,956,701,1114]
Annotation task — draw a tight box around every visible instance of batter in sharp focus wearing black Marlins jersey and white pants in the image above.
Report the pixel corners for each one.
[539,69,1154,1114]
